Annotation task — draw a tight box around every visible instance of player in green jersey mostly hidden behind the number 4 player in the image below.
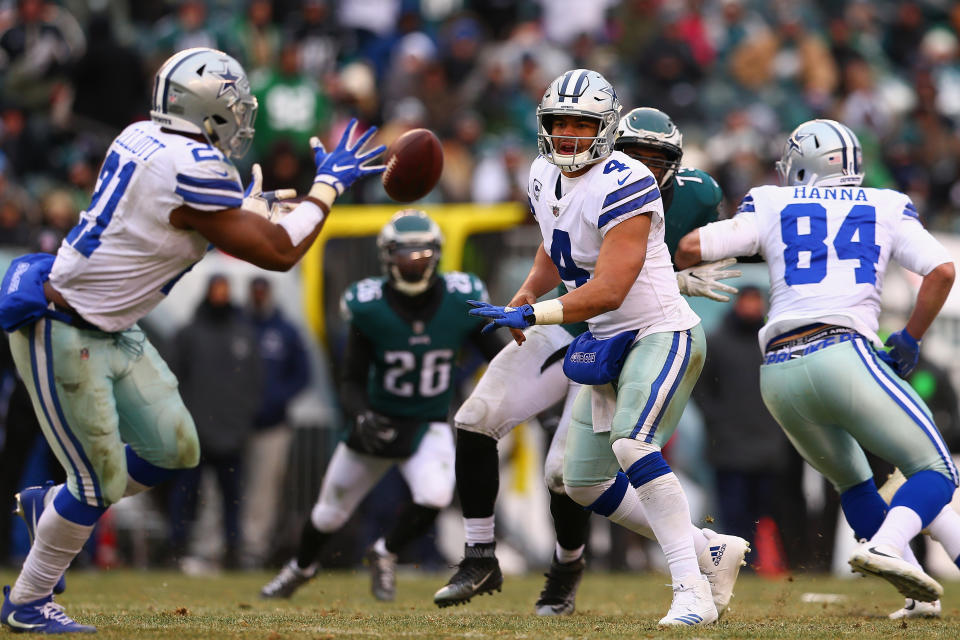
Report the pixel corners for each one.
[434,107,748,615]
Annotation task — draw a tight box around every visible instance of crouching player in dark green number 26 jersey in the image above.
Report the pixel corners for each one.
[260,209,503,600]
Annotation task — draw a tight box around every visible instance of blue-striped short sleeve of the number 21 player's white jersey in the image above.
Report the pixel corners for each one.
[174,150,243,211]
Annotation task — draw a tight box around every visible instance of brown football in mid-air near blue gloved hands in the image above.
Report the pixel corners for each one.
[382,129,443,202]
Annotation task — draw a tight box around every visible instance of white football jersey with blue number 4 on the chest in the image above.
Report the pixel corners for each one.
[527,151,700,338]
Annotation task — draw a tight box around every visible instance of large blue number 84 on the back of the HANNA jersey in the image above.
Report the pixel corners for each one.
[780,202,880,286]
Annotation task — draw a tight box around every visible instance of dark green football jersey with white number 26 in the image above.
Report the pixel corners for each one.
[341,271,488,420]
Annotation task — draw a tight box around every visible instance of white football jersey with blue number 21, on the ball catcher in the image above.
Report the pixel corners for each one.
[50,121,243,331]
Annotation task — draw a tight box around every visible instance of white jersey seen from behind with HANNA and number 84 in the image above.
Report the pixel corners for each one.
[700,186,952,349]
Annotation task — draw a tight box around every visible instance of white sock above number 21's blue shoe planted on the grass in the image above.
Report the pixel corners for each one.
[10,502,93,604]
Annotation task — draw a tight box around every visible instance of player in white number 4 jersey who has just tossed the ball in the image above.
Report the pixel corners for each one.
[458,69,732,626]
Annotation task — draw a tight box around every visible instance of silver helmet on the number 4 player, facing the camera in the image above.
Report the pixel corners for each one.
[537,69,620,171]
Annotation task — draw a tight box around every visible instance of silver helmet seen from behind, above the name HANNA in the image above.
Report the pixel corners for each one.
[777,120,863,187]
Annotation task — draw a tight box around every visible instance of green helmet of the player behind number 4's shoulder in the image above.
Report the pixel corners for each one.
[613,107,683,187]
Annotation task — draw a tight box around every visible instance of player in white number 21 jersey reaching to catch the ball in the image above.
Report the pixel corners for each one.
[0,48,384,633]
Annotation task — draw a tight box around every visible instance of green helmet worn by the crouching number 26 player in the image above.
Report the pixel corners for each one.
[377,209,443,296]
